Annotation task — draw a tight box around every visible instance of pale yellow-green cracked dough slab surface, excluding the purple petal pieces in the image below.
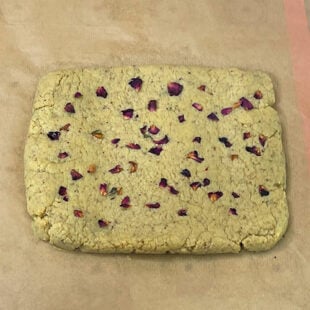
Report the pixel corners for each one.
[25,66,288,254]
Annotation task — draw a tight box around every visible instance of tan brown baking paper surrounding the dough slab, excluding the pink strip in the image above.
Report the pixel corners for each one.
[0,0,310,310]
